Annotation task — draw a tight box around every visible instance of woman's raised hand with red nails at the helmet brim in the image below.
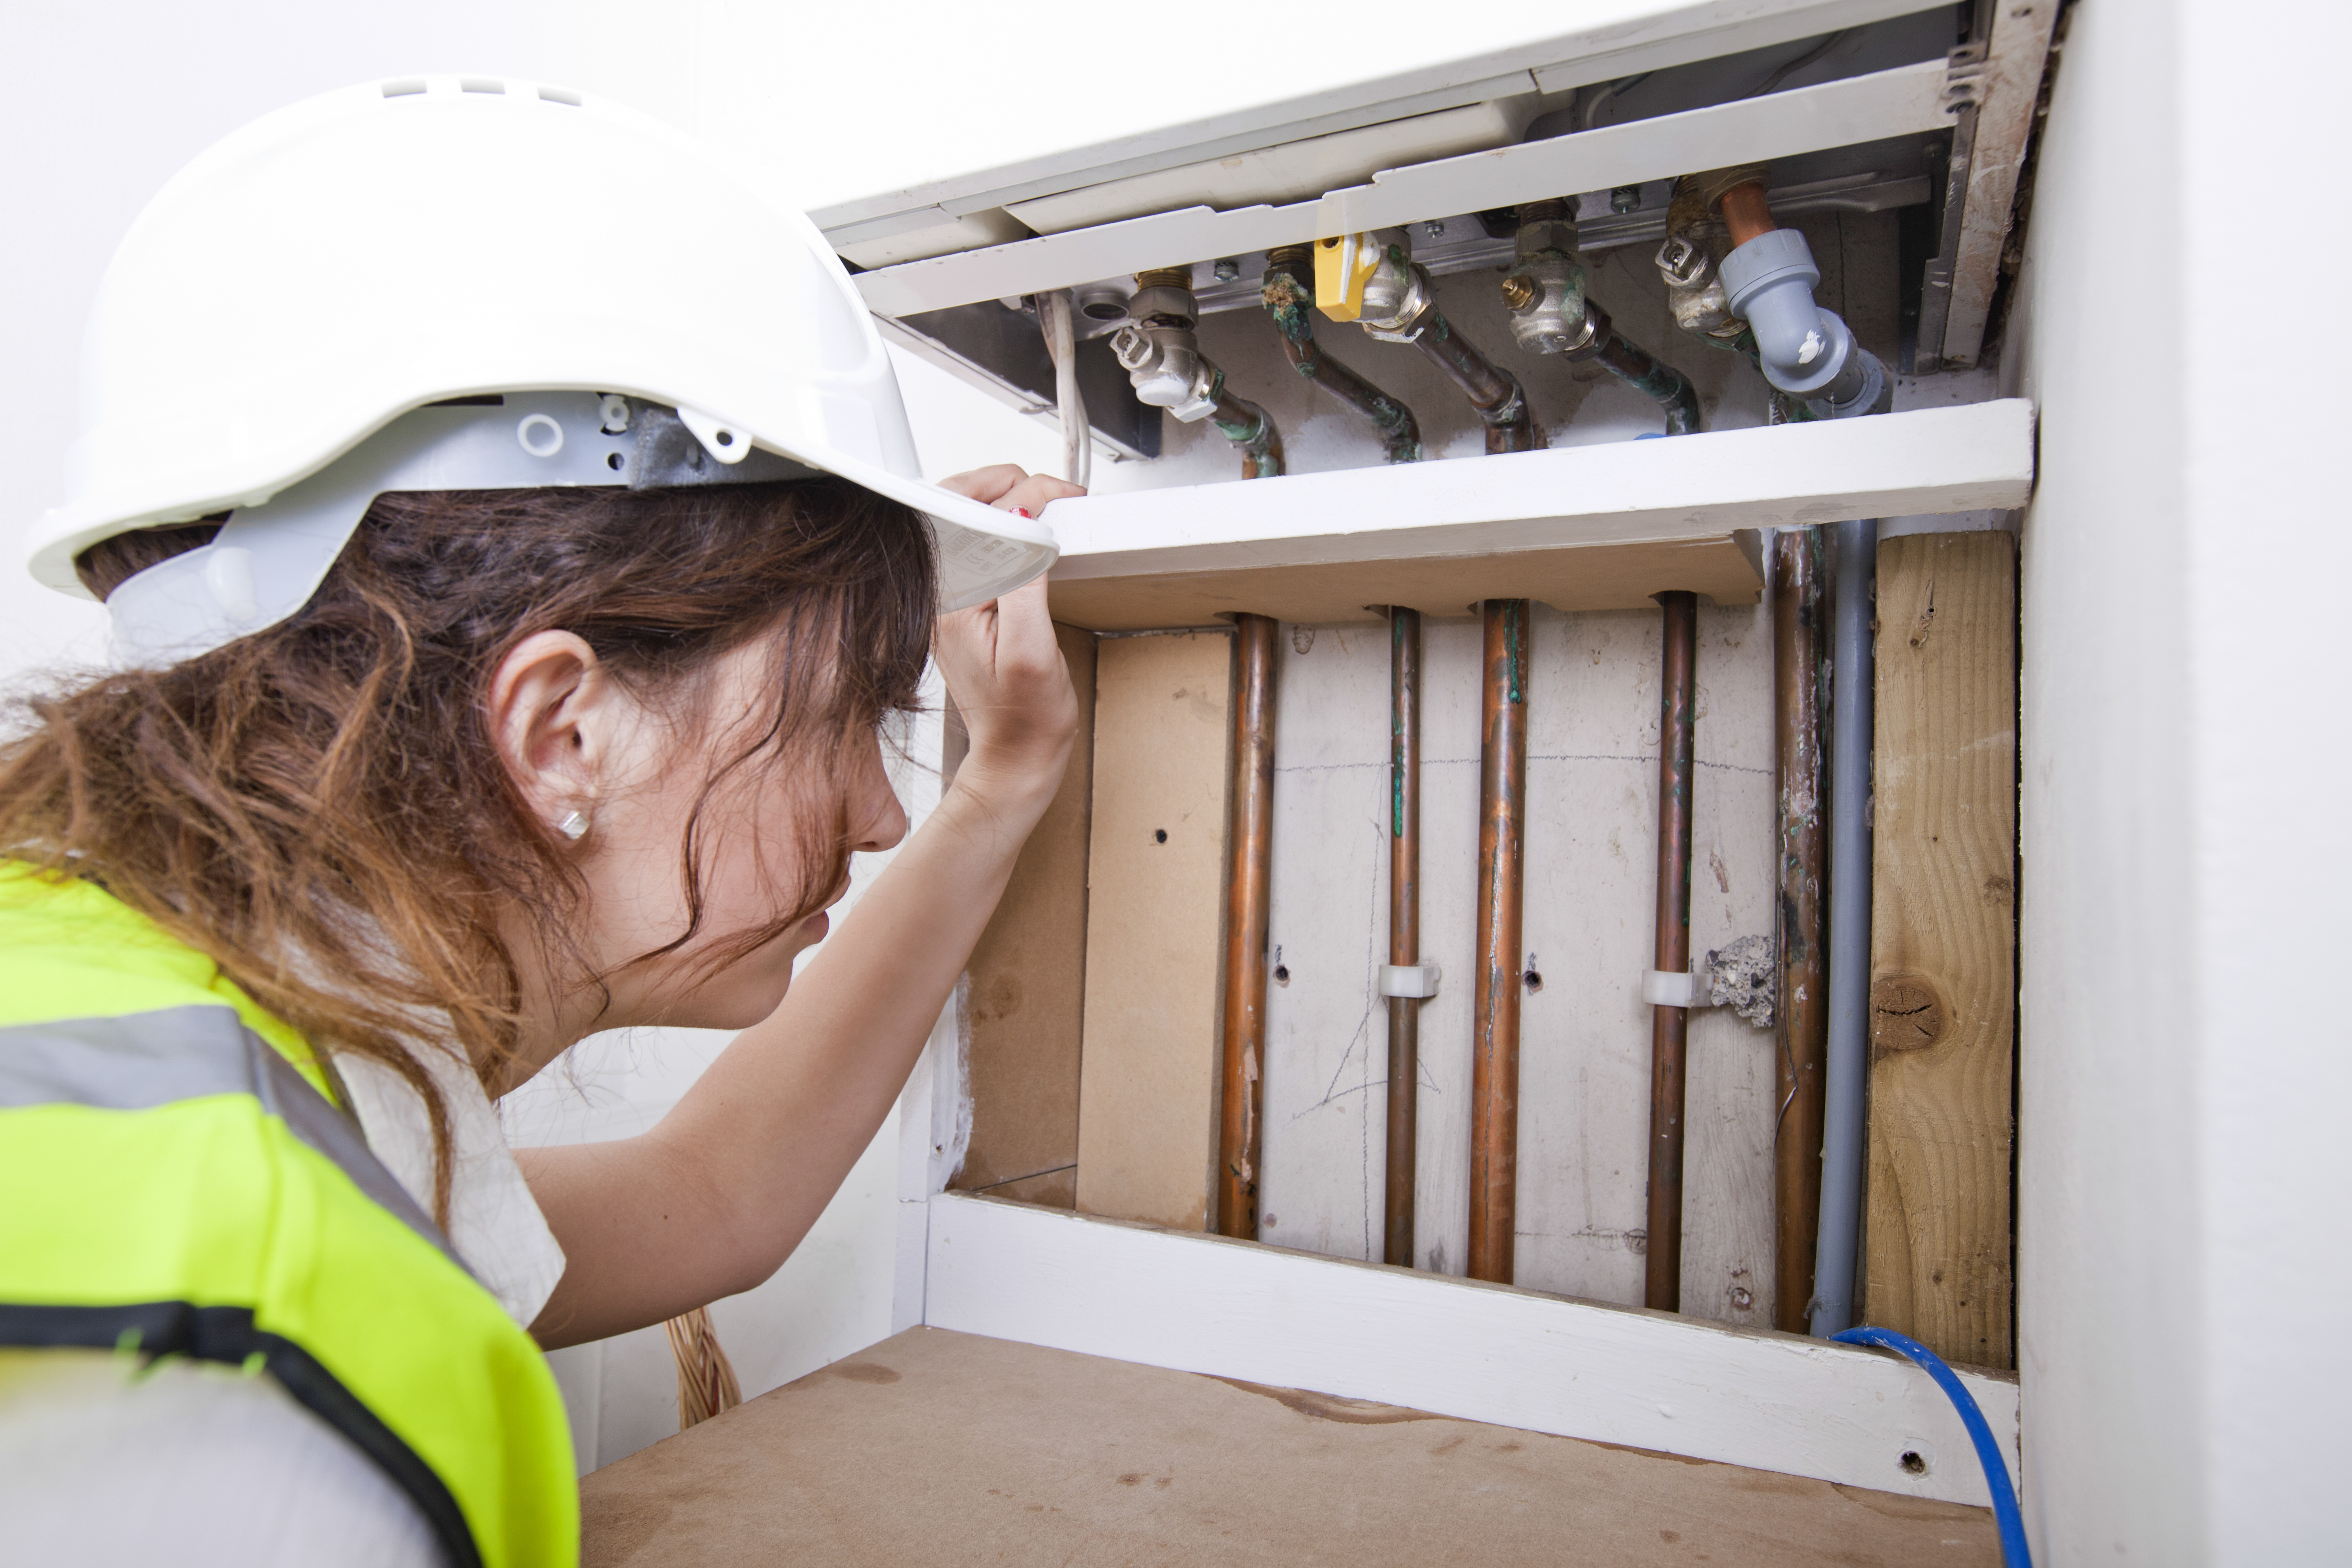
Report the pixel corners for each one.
[932,463,1087,821]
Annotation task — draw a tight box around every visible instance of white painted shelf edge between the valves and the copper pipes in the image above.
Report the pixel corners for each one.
[1044,397,2034,583]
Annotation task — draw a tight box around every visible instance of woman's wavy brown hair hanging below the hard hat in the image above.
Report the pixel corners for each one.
[0,480,936,1215]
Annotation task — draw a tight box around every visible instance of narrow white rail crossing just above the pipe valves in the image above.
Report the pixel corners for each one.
[856,61,1952,315]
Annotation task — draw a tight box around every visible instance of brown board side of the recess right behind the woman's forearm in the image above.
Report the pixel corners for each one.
[950,625,1096,1208]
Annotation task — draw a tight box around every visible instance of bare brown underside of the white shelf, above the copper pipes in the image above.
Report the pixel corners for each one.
[1047,534,1762,632]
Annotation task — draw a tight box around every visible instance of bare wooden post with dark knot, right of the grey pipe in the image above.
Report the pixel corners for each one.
[1863,534,2018,1366]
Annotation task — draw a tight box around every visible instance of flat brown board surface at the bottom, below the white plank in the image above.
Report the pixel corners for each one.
[581,1328,2001,1568]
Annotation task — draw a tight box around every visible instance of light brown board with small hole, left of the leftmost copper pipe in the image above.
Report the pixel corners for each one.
[1077,632,1233,1229]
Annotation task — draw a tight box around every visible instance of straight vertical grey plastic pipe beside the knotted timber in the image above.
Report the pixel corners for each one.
[1811,517,1879,1338]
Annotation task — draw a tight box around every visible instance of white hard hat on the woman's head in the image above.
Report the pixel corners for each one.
[28,78,1054,658]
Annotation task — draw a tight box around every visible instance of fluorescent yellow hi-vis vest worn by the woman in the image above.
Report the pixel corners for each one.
[0,863,579,1568]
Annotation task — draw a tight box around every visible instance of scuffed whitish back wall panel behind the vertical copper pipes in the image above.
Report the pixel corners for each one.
[1260,604,1778,1328]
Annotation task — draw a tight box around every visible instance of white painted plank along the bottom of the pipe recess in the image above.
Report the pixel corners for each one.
[922,1192,2018,1507]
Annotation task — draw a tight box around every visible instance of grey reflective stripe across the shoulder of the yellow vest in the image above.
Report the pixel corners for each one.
[0,1006,464,1267]
